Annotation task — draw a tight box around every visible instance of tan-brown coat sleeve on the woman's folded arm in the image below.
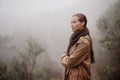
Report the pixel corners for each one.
[61,38,90,67]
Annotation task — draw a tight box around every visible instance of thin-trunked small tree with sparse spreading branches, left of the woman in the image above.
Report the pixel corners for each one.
[12,38,46,80]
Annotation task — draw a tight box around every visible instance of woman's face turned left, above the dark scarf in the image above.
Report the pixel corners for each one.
[71,16,84,32]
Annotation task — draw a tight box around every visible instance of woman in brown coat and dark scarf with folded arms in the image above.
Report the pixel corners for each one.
[61,13,94,80]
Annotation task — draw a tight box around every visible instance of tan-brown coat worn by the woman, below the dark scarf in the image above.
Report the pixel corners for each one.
[61,36,91,80]
